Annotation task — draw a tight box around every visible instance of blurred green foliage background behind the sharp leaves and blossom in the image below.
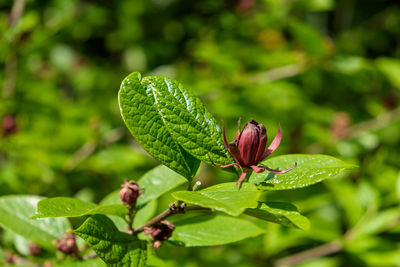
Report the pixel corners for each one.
[0,0,400,267]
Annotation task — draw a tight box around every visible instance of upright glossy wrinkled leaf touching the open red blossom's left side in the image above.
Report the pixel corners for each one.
[142,76,233,168]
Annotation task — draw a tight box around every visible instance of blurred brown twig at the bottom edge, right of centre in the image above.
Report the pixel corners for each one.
[275,241,343,266]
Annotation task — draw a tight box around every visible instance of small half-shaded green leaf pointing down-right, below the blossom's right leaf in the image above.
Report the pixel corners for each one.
[245,202,310,230]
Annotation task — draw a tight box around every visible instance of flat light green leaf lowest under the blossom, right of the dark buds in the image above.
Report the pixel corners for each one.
[171,214,264,247]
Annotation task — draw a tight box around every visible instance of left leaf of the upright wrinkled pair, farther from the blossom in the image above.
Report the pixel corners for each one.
[118,72,200,179]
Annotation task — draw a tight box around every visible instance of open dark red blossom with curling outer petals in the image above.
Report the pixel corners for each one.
[210,120,297,185]
